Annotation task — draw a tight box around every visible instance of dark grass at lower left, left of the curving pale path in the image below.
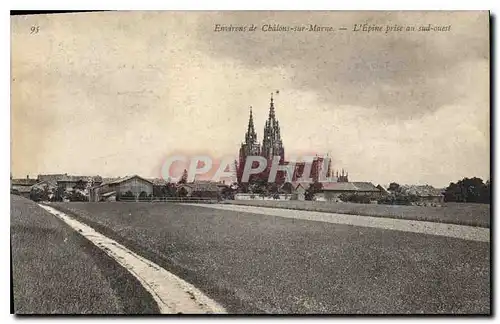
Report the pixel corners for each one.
[10,195,159,314]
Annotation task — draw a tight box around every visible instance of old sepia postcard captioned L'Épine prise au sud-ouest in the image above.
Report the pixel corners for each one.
[10,11,491,316]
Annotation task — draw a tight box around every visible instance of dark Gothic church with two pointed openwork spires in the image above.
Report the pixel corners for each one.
[236,93,349,184]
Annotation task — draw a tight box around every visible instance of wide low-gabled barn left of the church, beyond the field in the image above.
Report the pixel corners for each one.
[89,175,153,201]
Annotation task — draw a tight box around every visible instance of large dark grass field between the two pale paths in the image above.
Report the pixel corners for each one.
[42,201,490,314]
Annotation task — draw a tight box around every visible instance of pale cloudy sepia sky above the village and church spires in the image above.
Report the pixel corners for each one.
[11,11,490,187]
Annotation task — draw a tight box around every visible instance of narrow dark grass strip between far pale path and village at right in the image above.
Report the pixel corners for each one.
[225,200,490,228]
